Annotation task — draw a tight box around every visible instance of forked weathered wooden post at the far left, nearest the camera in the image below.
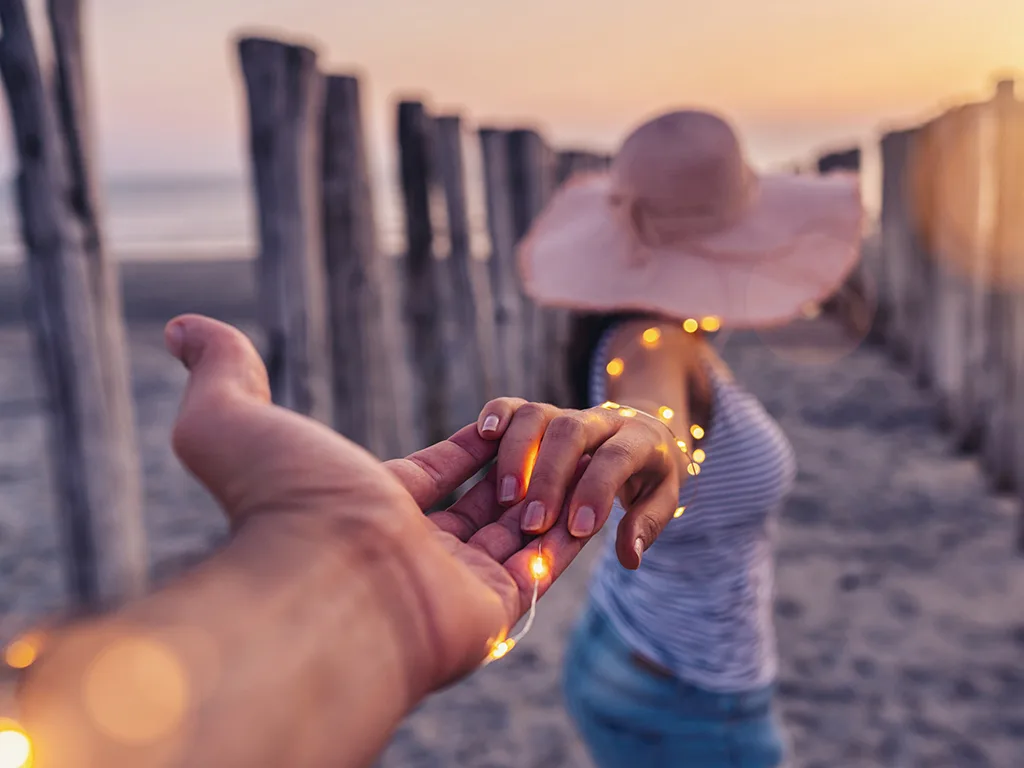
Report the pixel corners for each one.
[0,0,147,607]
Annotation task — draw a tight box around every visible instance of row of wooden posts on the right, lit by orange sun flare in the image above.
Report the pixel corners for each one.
[861,80,1024,549]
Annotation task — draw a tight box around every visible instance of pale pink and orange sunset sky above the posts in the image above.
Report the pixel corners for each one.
[6,0,1024,182]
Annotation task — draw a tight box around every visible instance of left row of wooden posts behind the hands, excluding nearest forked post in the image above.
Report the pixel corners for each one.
[239,38,608,466]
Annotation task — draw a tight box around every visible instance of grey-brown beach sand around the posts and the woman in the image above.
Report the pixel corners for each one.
[0,263,1024,768]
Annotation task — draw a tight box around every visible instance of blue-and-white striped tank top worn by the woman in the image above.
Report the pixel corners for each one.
[590,328,796,692]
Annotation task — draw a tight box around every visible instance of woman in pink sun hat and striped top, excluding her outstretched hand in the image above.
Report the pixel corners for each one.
[520,112,861,768]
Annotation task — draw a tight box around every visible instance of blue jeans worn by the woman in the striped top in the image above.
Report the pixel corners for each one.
[564,605,785,768]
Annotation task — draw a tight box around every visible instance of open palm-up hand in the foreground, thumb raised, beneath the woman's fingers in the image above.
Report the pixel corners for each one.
[167,315,584,696]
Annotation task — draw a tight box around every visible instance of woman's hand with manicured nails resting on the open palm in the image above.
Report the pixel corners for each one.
[477,397,682,568]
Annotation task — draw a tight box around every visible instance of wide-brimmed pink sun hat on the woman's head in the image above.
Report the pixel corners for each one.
[519,112,863,328]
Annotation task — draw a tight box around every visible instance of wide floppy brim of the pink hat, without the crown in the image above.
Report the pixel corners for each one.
[518,173,863,328]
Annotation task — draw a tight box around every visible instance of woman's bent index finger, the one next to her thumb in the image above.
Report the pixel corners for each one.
[568,422,678,537]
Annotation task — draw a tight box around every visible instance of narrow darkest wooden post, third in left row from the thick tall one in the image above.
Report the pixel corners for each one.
[398,101,450,442]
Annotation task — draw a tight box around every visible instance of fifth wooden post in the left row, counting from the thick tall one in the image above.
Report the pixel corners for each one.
[480,128,525,396]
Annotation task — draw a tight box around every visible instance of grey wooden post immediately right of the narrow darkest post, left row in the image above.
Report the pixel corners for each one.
[436,115,497,431]
